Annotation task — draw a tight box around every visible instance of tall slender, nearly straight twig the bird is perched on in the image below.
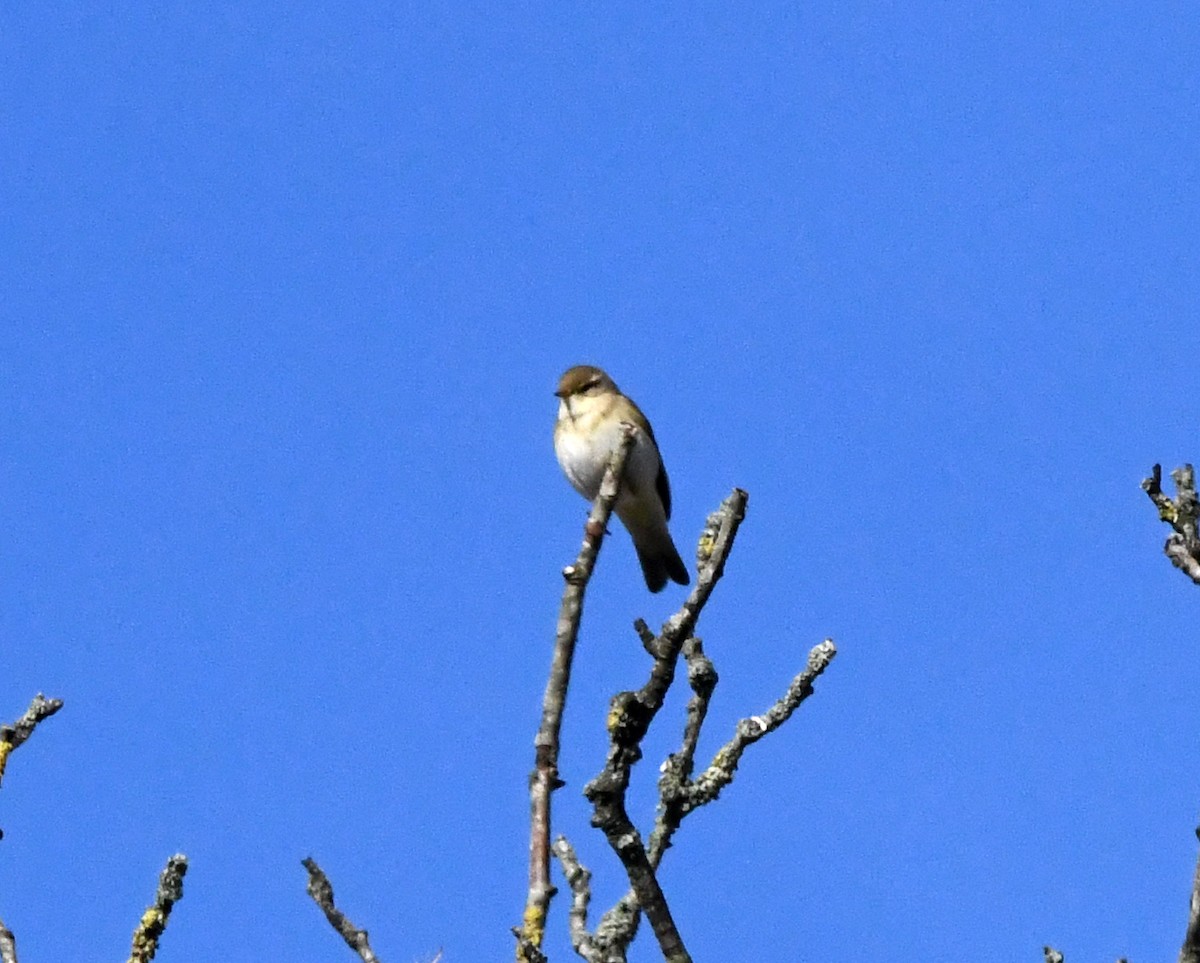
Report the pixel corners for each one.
[514,424,636,963]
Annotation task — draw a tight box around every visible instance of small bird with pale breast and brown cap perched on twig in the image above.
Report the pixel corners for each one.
[554,365,689,592]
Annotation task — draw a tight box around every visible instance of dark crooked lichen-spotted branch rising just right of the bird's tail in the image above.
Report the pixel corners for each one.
[583,489,749,963]
